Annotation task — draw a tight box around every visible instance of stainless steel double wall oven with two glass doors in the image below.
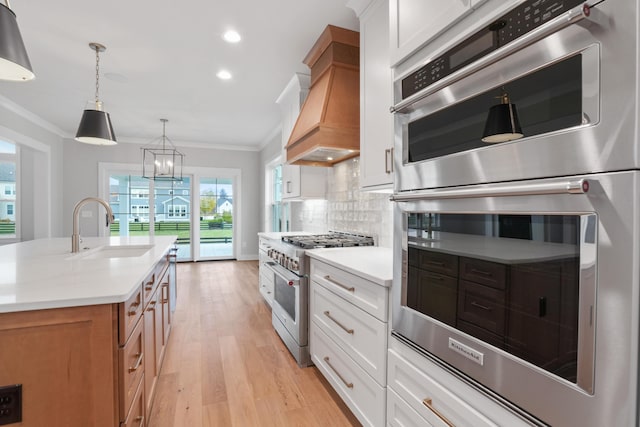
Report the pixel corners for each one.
[392,0,640,426]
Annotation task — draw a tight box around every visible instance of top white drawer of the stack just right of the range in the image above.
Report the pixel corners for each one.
[311,260,388,322]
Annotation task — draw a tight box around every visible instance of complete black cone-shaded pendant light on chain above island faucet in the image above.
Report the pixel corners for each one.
[76,43,117,145]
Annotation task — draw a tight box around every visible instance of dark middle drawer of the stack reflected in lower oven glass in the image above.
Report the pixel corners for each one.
[458,280,506,335]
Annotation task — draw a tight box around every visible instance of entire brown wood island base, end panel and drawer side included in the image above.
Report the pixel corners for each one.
[0,249,172,427]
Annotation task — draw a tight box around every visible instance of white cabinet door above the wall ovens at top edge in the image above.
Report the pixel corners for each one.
[389,0,471,64]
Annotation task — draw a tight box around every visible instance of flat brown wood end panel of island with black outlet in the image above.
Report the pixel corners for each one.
[0,305,118,427]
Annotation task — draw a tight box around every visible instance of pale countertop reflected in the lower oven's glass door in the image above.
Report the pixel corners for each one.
[409,231,579,264]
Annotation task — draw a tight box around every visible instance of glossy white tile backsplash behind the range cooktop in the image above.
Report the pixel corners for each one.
[291,157,393,247]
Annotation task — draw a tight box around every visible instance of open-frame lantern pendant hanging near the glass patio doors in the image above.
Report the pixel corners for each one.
[142,119,184,181]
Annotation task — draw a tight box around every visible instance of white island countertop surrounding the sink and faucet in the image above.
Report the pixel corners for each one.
[0,236,177,313]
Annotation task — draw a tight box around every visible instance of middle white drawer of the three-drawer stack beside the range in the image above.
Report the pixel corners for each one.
[310,282,387,387]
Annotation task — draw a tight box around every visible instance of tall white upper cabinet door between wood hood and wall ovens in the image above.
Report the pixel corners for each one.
[360,0,393,189]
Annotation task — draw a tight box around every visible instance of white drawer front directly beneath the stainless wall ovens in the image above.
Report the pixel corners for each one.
[388,350,497,427]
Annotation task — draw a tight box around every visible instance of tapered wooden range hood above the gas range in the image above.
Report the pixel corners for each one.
[285,25,360,166]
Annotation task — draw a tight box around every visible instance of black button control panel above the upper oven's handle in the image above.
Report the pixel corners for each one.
[402,0,584,99]
